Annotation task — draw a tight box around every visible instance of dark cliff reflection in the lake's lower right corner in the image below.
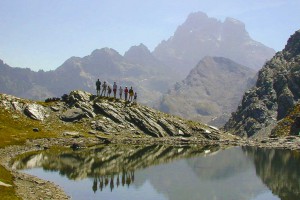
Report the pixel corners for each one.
[243,147,300,200]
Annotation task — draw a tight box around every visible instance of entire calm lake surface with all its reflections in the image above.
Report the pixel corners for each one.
[13,145,300,200]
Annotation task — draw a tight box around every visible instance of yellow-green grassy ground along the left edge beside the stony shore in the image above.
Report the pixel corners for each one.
[0,103,90,199]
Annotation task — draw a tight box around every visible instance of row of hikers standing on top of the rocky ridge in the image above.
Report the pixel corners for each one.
[96,79,137,102]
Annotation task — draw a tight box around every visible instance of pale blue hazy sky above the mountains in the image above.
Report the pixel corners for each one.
[0,0,300,70]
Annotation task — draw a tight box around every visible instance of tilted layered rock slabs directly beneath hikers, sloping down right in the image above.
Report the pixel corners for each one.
[60,91,225,140]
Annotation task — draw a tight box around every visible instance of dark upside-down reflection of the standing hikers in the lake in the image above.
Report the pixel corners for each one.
[92,171,134,193]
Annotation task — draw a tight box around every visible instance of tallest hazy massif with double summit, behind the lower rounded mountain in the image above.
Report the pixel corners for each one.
[153,12,275,78]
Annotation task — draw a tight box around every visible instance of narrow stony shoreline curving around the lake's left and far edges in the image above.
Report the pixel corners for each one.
[0,136,300,199]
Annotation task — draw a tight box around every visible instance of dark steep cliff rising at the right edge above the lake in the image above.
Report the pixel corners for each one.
[224,30,300,137]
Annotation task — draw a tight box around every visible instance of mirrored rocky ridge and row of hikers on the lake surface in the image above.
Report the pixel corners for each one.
[12,145,219,192]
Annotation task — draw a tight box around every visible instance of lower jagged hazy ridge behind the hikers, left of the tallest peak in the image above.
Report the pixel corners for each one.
[0,44,174,105]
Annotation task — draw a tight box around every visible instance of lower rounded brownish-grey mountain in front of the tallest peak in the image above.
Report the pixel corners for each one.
[159,57,255,126]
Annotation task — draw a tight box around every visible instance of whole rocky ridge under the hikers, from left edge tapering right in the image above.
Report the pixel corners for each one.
[0,91,236,141]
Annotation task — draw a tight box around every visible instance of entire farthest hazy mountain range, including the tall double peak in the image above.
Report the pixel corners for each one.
[0,12,274,119]
